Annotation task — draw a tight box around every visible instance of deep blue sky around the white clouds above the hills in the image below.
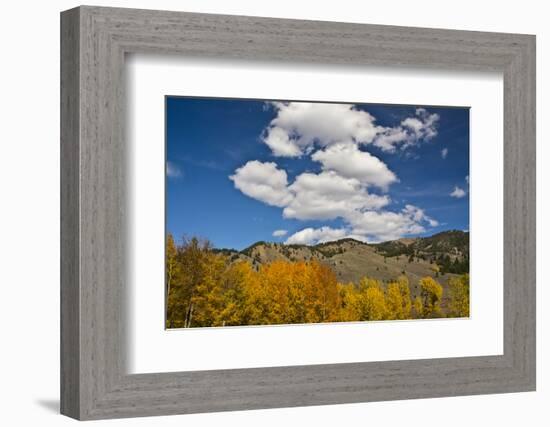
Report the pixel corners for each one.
[166,97,469,249]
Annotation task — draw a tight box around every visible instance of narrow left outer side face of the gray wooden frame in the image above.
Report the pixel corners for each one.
[60,10,80,417]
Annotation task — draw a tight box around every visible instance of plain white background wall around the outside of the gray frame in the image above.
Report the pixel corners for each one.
[0,0,550,427]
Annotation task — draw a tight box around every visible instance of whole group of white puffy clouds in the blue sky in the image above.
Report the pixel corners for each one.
[229,102,444,244]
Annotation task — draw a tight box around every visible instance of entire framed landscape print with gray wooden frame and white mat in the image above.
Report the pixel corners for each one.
[61,6,535,419]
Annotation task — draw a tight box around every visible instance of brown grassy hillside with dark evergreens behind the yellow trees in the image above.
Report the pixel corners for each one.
[215,230,469,304]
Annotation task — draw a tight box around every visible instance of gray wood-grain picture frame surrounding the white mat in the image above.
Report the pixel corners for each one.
[61,6,535,419]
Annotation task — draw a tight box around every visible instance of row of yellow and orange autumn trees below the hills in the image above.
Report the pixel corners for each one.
[166,235,469,328]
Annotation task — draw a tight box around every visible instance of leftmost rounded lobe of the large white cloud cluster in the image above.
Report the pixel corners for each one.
[229,160,292,207]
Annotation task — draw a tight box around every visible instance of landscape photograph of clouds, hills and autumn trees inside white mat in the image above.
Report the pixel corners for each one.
[164,95,470,329]
